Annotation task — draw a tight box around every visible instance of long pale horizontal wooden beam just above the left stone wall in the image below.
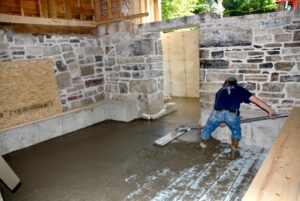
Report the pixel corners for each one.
[0,14,96,27]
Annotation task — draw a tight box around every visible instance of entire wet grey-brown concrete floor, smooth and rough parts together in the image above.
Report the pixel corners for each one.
[0,98,265,201]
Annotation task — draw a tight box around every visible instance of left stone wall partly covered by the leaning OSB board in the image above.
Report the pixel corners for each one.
[0,30,105,111]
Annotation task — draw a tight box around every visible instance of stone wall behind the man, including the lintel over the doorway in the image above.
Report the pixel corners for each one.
[139,11,300,112]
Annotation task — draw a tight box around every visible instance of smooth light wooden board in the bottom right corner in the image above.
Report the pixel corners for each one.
[243,107,300,201]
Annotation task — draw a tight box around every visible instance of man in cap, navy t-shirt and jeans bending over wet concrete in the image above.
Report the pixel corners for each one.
[200,77,275,159]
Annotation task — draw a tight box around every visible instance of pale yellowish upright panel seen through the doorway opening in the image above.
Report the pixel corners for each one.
[162,31,199,97]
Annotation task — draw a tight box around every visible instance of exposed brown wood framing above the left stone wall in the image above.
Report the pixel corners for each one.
[0,0,159,33]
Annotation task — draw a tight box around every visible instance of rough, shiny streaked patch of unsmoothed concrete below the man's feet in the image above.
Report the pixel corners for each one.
[124,141,266,201]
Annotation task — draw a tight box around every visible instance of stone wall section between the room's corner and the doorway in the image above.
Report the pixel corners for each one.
[98,22,164,115]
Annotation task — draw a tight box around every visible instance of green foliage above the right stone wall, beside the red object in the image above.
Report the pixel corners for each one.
[223,0,276,16]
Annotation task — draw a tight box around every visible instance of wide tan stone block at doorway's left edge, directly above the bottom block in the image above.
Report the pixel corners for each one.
[129,80,157,94]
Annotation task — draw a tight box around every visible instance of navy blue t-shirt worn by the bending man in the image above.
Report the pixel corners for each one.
[214,85,253,110]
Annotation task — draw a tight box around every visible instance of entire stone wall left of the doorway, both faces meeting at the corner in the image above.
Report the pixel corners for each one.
[0,21,164,115]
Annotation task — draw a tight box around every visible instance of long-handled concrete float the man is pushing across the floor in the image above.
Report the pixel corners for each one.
[154,114,288,147]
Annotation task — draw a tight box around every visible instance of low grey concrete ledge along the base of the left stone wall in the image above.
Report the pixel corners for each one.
[0,100,139,155]
